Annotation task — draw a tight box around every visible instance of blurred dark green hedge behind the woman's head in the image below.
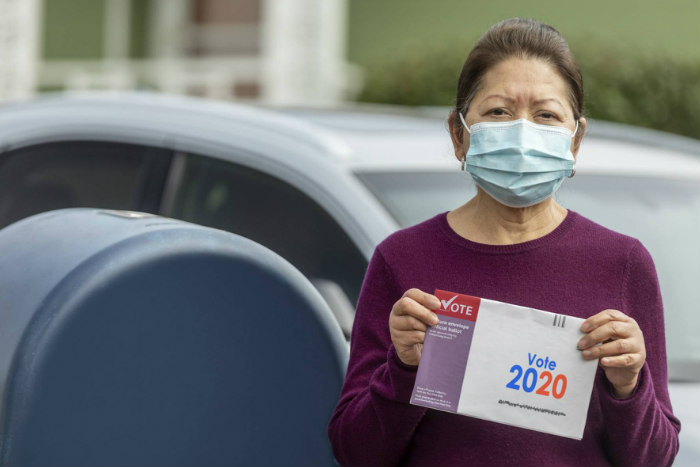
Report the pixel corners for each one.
[358,45,700,139]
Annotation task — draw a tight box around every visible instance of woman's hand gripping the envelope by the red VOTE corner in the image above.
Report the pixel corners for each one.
[389,289,440,365]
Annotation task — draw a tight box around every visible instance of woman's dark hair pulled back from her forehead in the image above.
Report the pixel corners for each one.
[451,18,583,141]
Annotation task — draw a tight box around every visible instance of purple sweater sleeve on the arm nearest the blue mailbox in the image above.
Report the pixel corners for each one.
[328,245,427,466]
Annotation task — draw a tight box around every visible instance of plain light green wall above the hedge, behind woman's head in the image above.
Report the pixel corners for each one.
[349,0,700,65]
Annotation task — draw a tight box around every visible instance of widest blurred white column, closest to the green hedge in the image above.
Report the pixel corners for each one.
[261,0,347,105]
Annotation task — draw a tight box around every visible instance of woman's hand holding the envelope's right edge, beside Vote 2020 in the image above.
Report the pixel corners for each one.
[578,310,647,399]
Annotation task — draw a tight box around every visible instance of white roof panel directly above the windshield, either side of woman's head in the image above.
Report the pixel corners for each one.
[276,106,700,179]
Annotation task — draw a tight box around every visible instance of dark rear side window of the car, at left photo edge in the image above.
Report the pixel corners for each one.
[0,141,170,228]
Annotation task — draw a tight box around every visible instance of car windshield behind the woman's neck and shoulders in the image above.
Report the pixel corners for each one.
[357,171,700,381]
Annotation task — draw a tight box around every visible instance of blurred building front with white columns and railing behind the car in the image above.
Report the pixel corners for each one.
[6,0,361,105]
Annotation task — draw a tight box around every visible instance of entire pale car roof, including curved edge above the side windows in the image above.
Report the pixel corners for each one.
[0,92,700,179]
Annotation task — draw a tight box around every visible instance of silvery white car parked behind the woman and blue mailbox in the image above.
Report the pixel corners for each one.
[0,93,700,466]
